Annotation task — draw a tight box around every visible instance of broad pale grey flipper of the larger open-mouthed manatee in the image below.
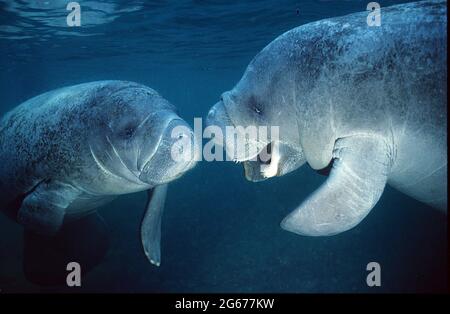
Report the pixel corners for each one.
[281,136,391,236]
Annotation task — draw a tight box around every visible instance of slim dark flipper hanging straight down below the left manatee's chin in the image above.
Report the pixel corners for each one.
[141,184,167,266]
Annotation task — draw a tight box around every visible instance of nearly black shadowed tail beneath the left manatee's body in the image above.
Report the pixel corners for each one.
[23,213,109,286]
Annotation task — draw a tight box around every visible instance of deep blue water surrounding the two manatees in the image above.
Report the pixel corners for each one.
[0,0,448,293]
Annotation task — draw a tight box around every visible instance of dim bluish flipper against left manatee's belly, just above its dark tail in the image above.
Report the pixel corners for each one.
[17,181,80,235]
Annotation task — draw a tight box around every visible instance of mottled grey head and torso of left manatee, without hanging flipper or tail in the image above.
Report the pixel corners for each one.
[0,81,194,264]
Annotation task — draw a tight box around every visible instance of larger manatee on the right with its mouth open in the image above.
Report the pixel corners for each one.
[208,0,447,236]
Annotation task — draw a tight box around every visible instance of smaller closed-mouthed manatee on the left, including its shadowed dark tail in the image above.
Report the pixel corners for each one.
[0,81,198,282]
